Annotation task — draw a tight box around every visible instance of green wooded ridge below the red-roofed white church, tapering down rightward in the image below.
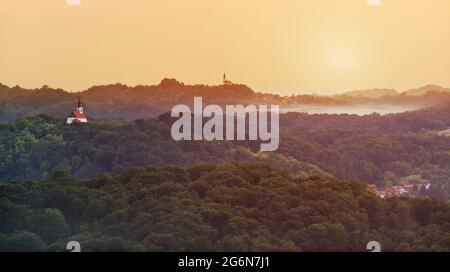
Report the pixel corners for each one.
[0,115,330,180]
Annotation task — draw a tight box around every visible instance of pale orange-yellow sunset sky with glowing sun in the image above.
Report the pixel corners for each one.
[0,0,450,94]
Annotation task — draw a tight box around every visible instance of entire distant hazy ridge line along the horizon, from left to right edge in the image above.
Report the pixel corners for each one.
[0,79,450,121]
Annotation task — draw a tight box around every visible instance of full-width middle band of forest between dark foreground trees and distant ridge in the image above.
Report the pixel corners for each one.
[0,103,450,199]
